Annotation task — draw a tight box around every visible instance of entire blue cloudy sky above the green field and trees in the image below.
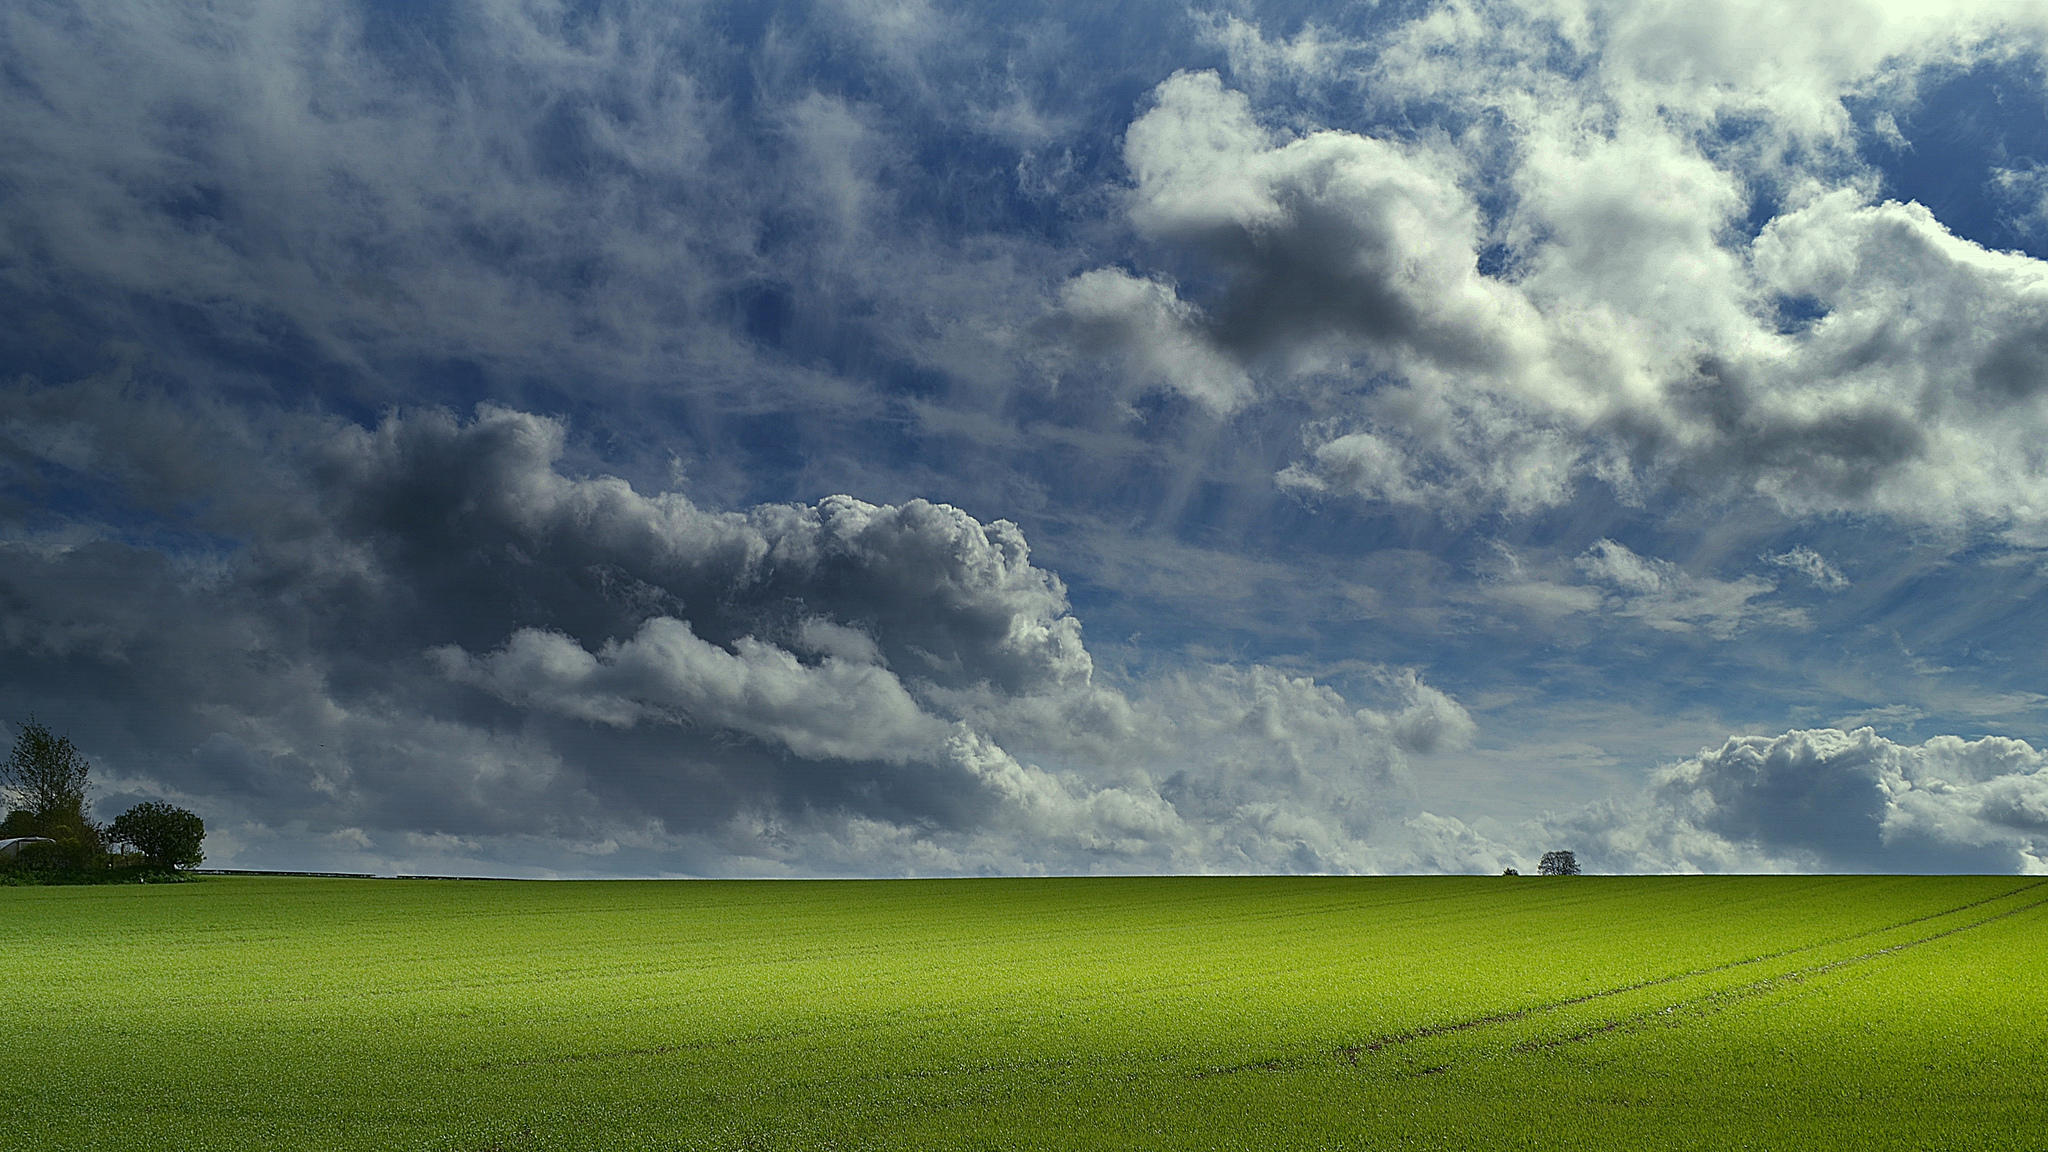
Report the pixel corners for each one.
[0,0,2048,877]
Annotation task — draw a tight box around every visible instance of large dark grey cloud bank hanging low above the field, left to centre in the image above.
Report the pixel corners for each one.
[0,387,1475,873]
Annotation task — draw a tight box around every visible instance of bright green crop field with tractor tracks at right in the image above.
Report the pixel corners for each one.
[0,877,2048,1150]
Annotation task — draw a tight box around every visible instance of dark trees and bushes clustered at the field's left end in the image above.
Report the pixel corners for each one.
[0,715,207,879]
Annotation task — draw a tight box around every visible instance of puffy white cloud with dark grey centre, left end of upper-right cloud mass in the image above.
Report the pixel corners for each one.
[1124,72,1526,371]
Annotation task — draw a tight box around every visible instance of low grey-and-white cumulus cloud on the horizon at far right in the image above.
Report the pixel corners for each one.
[1548,728,2048,873]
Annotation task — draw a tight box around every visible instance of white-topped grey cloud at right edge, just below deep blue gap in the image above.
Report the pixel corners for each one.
[1737,193,2048,523]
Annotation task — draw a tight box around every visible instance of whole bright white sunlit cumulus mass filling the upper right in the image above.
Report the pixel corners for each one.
[1075,4,2048,529]
